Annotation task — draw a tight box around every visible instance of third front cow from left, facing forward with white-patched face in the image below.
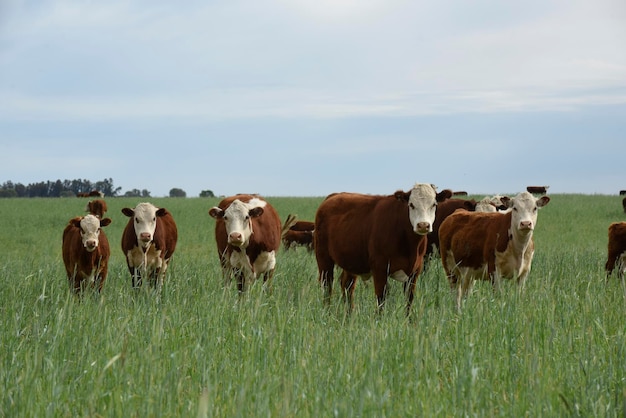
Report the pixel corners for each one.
[209,194,281,292]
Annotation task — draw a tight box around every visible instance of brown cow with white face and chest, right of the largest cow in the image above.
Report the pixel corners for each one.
[439,192,550,310]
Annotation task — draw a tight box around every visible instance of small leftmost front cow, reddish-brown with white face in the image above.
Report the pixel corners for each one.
[63,215,111,295]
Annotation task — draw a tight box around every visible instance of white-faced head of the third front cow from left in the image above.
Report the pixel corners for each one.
[209,198,265,248]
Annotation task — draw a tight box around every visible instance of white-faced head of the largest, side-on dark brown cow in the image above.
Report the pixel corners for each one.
[395,183,452,235]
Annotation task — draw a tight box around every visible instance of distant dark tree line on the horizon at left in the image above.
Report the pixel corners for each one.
[0,178,215,198]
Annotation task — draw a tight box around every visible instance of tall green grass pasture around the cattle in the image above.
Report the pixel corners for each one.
[0,194,626,417]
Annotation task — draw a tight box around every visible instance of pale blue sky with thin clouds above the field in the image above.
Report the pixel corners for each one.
[0,0,626,197]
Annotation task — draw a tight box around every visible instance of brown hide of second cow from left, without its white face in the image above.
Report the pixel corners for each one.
[122,208,178,287]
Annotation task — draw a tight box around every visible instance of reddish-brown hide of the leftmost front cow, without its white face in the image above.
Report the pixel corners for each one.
[62,216,111,294]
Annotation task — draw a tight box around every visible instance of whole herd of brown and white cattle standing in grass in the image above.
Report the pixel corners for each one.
[63,183,626,314]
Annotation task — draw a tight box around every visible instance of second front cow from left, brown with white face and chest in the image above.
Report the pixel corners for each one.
[122,203,178,289]
